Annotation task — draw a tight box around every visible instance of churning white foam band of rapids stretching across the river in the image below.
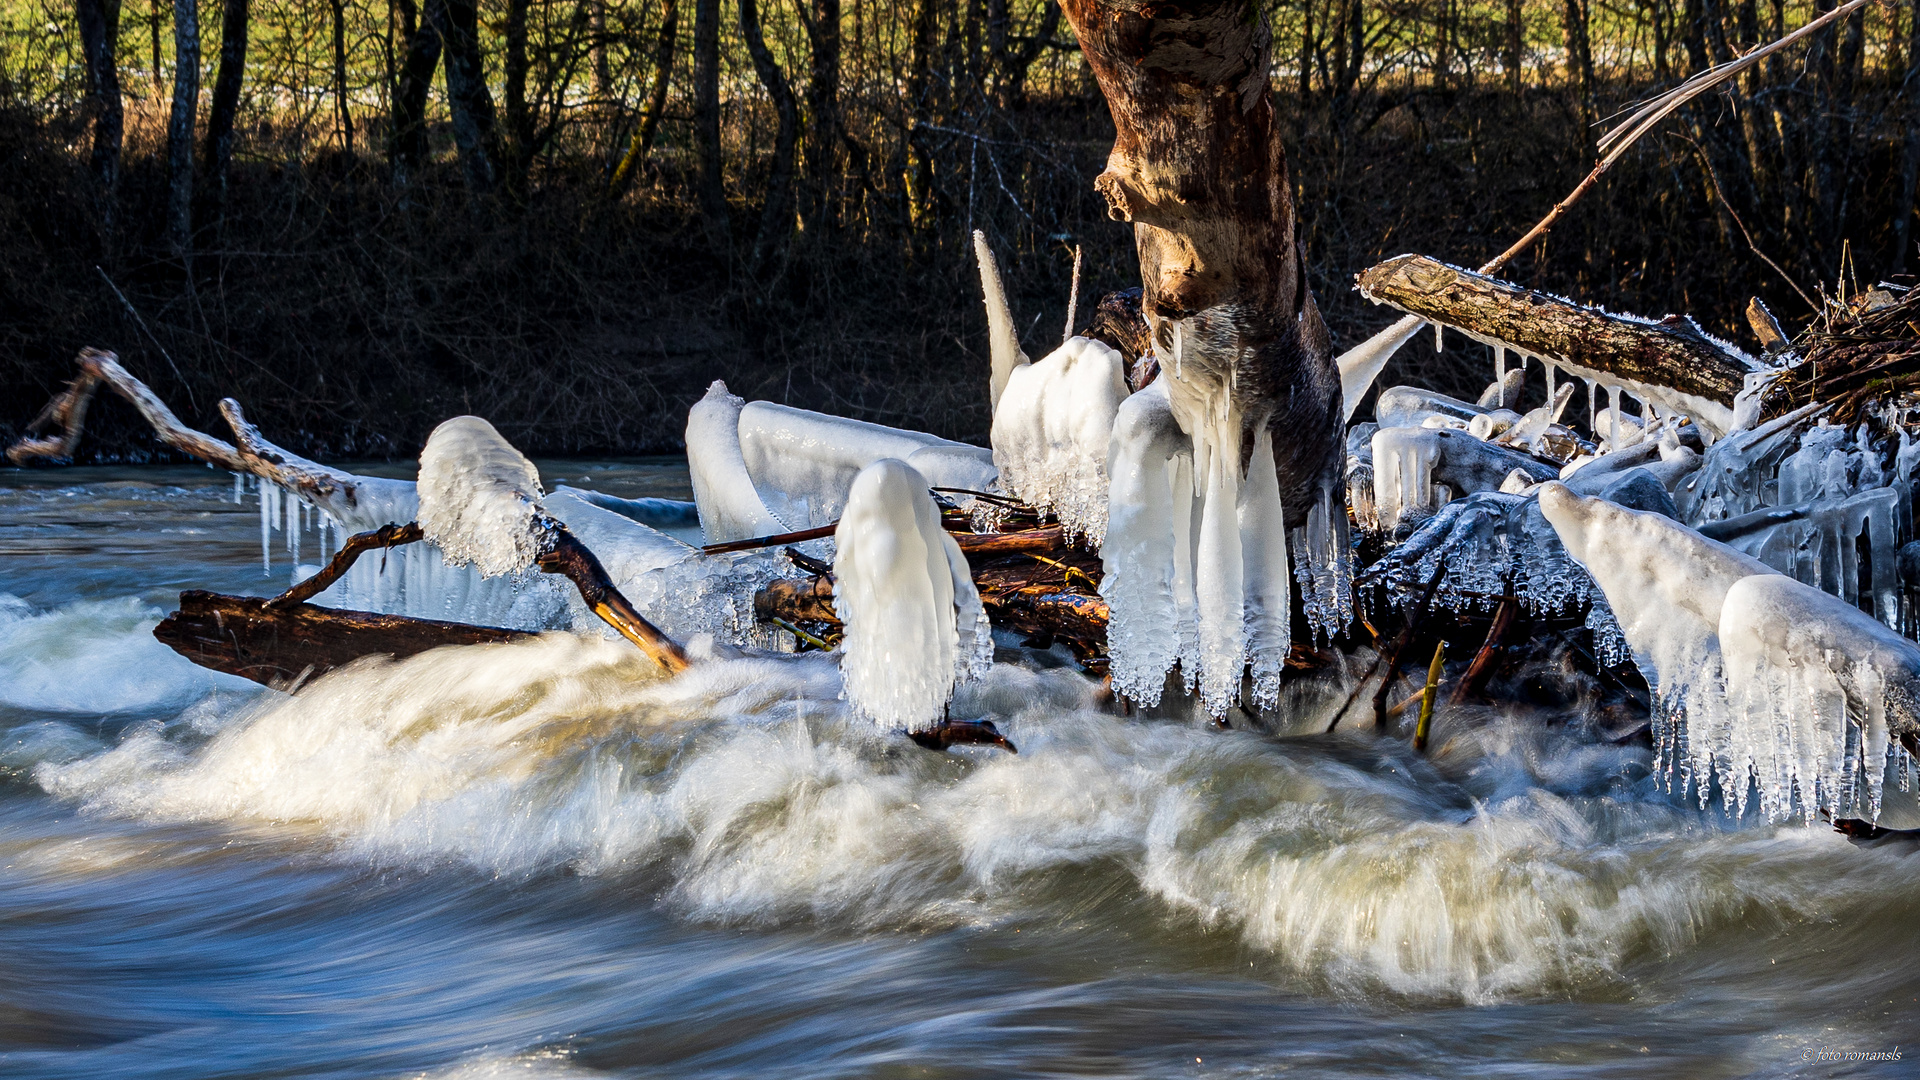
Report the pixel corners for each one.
[36,622,1920,1001]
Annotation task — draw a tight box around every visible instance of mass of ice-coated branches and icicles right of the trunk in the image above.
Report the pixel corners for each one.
[1348,326,1920,819]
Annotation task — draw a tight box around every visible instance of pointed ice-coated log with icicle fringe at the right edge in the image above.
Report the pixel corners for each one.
[1540,484,1920,821]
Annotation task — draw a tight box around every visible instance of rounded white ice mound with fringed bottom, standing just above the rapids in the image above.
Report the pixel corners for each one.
[833,457,993,728]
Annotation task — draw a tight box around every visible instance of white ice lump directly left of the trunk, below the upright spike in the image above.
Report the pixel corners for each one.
[993,338,1127,548]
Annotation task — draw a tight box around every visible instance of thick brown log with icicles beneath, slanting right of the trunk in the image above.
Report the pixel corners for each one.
[1357,256,1764,434]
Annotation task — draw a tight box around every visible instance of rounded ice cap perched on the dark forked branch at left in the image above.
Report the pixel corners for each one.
[419,417,540,577]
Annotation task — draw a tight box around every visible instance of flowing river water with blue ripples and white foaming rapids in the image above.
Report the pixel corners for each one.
[0,461,1920,1078]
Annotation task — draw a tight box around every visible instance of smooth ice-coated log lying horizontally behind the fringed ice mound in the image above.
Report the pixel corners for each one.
[737,397,998,530]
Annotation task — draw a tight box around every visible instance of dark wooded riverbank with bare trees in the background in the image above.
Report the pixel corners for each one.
[0,0,1920,457]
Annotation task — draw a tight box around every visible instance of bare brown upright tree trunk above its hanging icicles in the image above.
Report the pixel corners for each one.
[1064,0,1342,527]
